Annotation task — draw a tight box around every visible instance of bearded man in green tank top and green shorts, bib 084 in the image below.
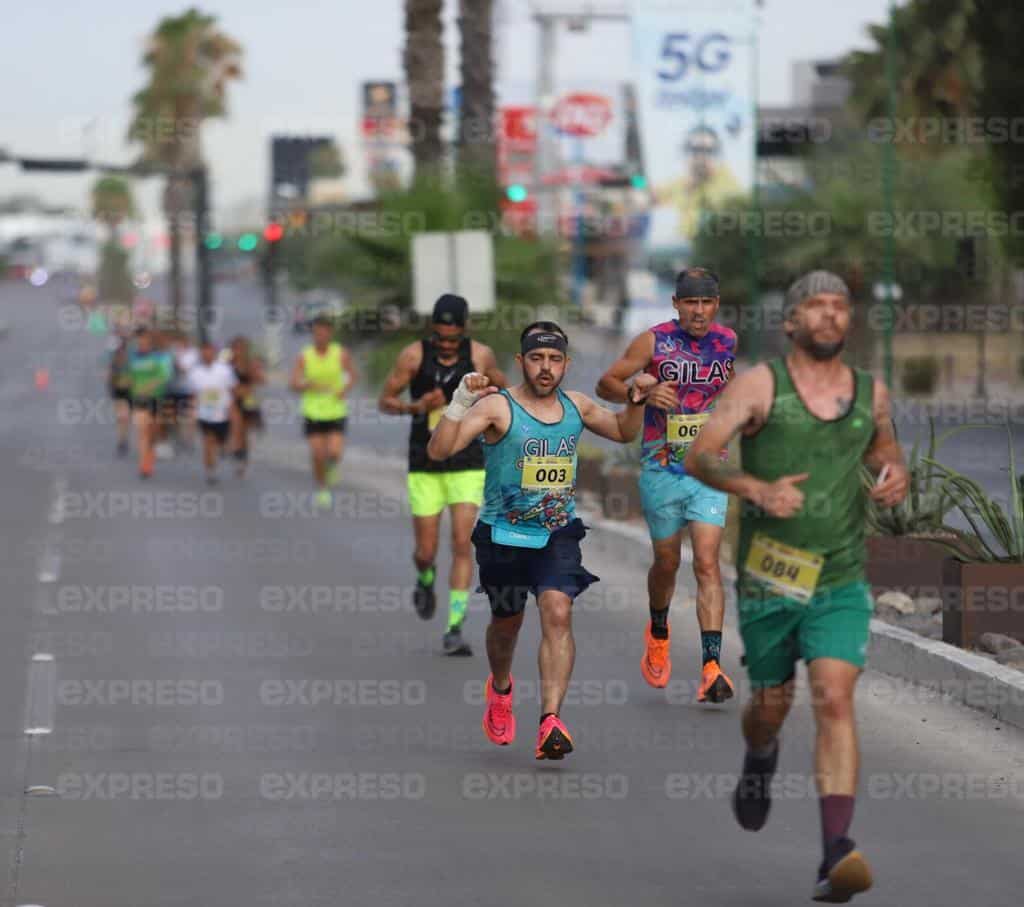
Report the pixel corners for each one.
[686,271,908,903]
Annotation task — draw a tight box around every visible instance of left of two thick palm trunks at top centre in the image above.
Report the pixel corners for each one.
[402,0,444,179]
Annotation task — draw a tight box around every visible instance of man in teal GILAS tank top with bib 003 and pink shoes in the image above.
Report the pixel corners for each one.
[427,321,656,760]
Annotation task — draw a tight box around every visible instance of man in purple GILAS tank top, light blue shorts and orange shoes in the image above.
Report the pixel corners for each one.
[597,267,736,702]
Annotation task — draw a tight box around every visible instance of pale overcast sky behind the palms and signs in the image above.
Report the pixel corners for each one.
[0,0,889,225]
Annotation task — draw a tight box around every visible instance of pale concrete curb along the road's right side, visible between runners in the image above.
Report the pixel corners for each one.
[269,442,1024,729]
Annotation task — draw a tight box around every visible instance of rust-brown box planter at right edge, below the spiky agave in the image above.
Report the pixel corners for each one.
[942,558,1024,649]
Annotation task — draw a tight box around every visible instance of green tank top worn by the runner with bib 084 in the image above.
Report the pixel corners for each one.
[736,359,874,598]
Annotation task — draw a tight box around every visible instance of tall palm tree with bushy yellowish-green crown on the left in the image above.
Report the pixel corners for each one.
[128,8,242,325]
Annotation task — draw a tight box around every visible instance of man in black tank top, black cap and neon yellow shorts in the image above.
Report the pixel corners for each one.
[380,293,505,655]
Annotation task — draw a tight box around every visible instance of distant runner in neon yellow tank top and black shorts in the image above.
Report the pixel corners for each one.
[290,317,357,510]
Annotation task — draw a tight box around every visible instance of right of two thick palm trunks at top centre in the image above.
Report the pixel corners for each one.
[459,0,495,183]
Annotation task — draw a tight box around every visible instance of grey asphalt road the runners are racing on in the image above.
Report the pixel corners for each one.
[0,285,1024,907]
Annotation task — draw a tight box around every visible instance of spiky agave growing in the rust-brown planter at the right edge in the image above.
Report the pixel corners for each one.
[924,423,1024,564]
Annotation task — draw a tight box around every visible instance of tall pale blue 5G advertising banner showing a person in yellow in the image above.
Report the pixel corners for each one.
[633,0,756,253]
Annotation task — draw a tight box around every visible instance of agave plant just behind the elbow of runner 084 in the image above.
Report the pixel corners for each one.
[861,418,963,535]
